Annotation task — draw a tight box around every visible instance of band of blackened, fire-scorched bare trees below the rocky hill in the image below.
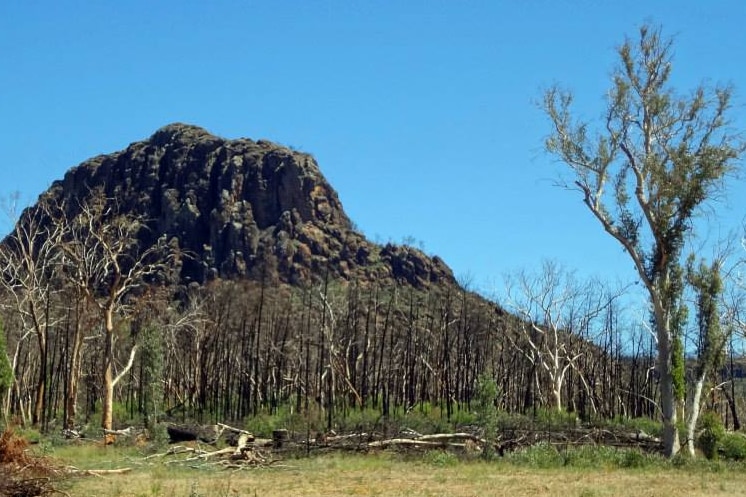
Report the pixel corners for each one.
[3,274,720,427]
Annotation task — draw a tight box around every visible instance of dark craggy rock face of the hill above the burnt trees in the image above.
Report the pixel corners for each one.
[46,124,454,288]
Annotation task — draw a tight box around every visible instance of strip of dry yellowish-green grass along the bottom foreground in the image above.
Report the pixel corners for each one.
[61,455,746,497]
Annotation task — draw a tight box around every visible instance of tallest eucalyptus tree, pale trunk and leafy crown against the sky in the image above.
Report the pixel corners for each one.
[543,25,744,456]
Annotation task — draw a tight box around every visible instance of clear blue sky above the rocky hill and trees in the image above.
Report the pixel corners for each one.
[0,0,746,293]
